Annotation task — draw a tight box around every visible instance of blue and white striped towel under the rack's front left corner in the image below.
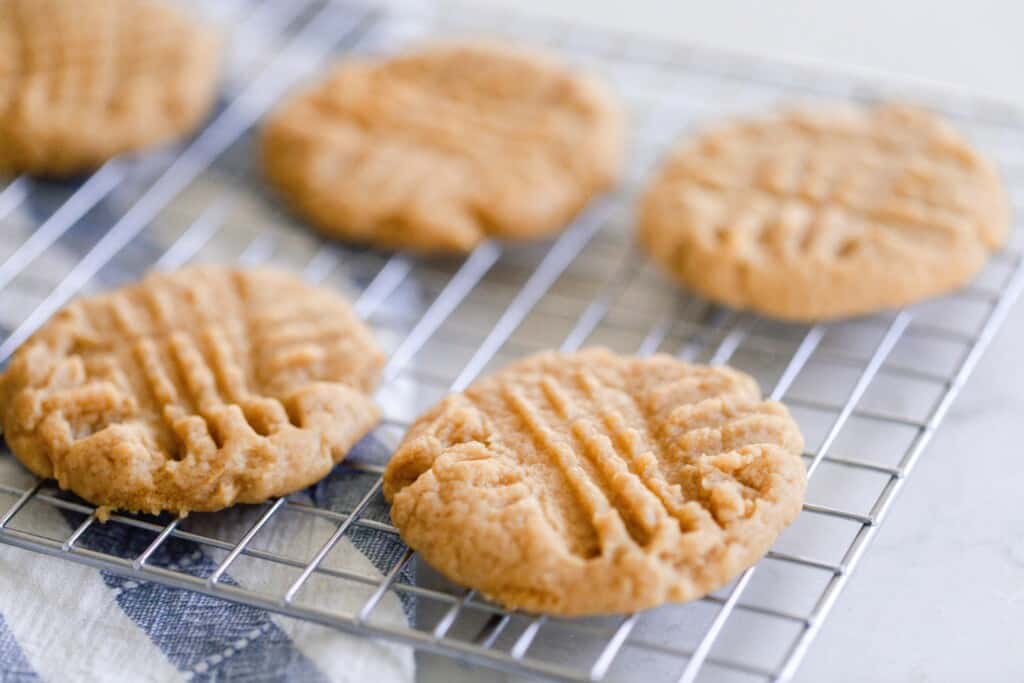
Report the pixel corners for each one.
[0,432,414,683]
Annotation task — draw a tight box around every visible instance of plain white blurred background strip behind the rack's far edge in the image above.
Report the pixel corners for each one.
[468,0,1024,102]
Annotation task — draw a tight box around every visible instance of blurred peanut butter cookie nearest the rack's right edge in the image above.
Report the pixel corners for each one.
[637,104,1010,321]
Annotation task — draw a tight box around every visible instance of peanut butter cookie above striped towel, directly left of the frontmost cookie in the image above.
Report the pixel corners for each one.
[0,266,383,514]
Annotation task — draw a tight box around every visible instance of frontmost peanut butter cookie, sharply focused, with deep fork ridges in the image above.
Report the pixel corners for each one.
[384,348,806,615]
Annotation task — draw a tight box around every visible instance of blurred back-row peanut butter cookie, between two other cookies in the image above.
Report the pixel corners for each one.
[261,42,624,252]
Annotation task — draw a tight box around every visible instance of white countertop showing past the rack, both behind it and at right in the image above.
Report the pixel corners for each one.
[442,0,1024,683]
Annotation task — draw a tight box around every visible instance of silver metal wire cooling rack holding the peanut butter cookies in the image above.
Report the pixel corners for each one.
[0,0,1024,681]
